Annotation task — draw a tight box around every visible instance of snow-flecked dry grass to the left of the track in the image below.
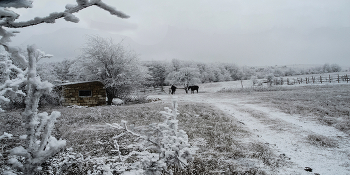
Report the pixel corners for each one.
[0,103,284,174]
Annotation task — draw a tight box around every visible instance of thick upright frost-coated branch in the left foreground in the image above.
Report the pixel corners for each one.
[10,46,66,174]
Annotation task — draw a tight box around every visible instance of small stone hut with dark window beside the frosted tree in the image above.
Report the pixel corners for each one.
[55,81,106,107]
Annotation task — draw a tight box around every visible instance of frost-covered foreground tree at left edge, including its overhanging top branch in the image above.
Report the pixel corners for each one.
[0,0,128,175]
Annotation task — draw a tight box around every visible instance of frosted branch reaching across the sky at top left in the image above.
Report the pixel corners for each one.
[0,0,129,28]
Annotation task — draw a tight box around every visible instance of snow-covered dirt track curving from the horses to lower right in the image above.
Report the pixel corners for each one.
[150,93,350,175]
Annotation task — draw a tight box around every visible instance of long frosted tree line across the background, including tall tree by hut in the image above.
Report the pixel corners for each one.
[37,36,341,100]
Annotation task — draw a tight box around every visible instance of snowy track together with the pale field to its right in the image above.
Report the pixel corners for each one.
[150,81,350,175]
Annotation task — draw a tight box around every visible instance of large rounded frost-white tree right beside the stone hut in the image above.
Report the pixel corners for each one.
[73,36,149,105]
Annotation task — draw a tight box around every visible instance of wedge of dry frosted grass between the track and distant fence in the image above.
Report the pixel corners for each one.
[219,84,350,134]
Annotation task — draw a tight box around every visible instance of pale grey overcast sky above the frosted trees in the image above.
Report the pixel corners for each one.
[7,0,350,66]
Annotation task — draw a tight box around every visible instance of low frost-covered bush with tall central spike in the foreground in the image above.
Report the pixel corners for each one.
[108,98,196,174]
